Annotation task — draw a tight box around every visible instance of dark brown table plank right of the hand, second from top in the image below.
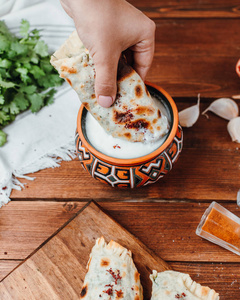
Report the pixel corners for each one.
[147,19,240,97]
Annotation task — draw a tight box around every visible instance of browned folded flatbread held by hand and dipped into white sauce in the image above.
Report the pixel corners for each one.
[51,31,169,142]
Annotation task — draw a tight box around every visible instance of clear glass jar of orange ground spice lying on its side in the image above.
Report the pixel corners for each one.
[196,202,240,255]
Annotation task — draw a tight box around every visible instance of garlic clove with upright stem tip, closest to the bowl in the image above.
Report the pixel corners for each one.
[179,94,200,127]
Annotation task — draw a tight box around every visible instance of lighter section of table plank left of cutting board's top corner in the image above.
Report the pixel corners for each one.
[0,201,86,259]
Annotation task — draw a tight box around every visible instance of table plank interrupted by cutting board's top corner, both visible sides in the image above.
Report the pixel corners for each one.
[0,201,240,262]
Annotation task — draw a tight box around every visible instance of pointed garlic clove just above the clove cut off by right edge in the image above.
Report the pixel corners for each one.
[202,98,239,120]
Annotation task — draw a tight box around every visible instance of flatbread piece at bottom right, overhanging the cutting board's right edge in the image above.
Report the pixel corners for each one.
[150,271,219,300]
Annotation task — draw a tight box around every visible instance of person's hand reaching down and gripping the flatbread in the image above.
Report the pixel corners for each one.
[60,0,155,107]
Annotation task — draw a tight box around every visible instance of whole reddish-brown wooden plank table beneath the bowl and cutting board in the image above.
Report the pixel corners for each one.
[0,0,240,300]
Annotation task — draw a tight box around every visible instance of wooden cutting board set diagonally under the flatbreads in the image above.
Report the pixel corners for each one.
[0,201,169,300]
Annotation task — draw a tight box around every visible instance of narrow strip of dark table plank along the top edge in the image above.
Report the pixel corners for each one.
[129,0,240,18]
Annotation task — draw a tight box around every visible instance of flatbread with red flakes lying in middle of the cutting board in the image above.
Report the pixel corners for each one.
[80,237,143,300]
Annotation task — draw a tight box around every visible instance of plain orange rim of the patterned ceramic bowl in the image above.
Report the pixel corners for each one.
[77,81,178,166]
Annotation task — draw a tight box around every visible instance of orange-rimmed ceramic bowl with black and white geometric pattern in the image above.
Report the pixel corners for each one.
[76,82,183,188]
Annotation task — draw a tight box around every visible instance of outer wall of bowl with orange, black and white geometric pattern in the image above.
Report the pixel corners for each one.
[76,125,183,188]
